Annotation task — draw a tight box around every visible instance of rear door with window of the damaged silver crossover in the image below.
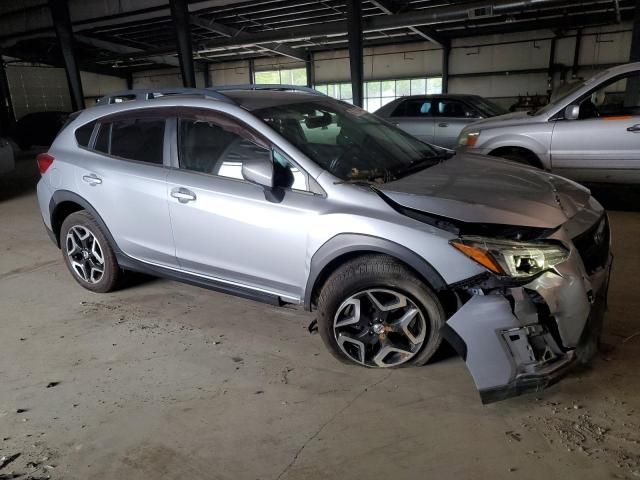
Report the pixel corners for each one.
[76,109,177,267]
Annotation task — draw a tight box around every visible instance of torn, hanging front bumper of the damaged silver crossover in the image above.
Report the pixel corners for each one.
[442,204,613,403]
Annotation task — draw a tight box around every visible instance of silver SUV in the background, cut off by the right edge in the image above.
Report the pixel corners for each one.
[458,63,640,184]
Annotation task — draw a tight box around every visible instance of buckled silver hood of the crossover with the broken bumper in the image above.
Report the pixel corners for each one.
[377,153,590,228]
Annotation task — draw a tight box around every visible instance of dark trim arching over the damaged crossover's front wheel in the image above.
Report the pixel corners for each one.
[304,233,447,311]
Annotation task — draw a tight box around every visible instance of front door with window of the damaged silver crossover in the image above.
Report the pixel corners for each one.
[168,112,324,300]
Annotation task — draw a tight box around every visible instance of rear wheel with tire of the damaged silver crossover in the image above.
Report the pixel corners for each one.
[60,210,121,293]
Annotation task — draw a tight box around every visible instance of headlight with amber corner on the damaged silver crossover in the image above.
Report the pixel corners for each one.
[449,237,569,278]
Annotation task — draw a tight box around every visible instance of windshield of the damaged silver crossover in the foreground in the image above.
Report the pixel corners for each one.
[252,98,451,183]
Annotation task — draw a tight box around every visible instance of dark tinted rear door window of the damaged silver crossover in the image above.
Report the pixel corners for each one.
[95,118,165,165]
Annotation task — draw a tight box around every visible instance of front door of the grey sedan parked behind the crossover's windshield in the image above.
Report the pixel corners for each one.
[431,98,480,148]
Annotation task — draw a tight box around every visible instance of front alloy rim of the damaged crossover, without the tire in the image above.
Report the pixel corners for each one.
[333,289,427,367]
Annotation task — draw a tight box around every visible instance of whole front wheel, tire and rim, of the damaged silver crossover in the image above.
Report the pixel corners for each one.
[318,254,445,368]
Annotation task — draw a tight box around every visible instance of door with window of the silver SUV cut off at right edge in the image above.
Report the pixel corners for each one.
[551,72,640,183]
